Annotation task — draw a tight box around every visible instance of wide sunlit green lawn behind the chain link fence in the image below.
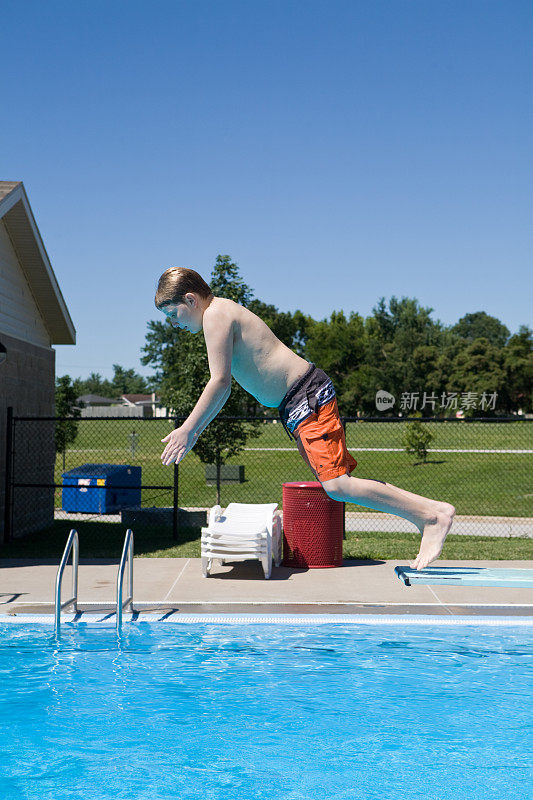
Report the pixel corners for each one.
[51,419,533,520]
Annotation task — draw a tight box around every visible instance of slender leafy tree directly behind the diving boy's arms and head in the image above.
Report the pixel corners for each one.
[141,255,261,503]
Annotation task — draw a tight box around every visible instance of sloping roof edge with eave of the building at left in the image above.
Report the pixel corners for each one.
[0,181,76,344]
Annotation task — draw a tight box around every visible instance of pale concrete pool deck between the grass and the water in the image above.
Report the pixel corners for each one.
[0,558,533,618]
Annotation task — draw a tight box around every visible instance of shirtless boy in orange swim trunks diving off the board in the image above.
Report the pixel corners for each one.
[155,267,455,570]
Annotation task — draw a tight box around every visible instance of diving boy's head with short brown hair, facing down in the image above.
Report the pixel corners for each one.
[155,267,213,333]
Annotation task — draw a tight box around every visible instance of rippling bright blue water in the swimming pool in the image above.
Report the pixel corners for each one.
[0,622,533,800]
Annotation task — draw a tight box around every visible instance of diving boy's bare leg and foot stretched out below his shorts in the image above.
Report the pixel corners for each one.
[322,475,455,570]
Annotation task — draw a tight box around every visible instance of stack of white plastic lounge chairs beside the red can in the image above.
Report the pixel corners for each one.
[202,503,281,578]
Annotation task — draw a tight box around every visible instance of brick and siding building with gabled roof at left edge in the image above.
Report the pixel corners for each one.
[0,181,76,541]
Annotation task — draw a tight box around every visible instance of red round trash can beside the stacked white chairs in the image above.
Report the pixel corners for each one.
[283,481,344,569]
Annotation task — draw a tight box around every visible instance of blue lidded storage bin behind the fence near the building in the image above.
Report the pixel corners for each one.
[61,464,141,514]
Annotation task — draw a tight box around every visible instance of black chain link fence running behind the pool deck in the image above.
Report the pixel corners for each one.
[4,415,533,541]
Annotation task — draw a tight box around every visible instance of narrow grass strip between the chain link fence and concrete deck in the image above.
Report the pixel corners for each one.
[0,520,533,564]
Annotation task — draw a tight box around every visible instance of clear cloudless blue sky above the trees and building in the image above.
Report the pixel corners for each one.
[0,0,533,377]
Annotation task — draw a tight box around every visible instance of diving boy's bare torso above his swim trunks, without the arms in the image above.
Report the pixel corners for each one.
[204,297,309,408]
